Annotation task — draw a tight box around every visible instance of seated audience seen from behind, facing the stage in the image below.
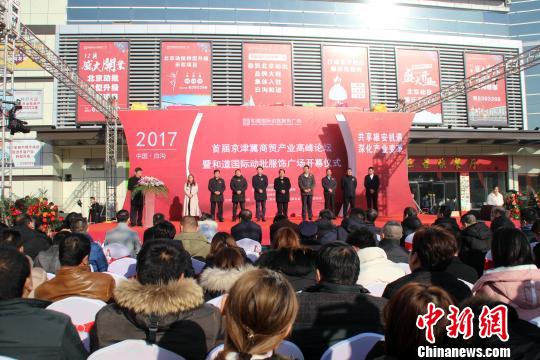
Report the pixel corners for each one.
[0,207,540,360]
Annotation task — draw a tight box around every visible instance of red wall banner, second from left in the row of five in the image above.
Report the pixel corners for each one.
[161,42,212,109]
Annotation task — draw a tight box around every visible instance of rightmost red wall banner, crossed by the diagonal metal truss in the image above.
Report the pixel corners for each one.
[396,49,442,124]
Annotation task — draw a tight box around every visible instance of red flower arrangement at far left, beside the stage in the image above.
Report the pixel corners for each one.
[10,197,64,232]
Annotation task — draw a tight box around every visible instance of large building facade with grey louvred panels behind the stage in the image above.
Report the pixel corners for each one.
[9,0,540,211]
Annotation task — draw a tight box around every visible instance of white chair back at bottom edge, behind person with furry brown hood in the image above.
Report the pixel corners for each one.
[88,340,185,360]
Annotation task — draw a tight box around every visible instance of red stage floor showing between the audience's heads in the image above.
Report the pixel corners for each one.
[88,215,440,245]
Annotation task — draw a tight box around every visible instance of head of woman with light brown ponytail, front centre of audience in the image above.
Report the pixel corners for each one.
[217,269,298,360]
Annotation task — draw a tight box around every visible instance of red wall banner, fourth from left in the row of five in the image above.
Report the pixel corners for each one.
[322,46,370,111]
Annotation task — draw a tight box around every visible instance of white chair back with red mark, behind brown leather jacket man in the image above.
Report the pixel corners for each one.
[47,296,107,350]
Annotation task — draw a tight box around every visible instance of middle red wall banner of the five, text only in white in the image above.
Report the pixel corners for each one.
[242,43,292,105]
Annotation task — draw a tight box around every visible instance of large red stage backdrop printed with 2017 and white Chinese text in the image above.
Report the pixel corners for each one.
[120,106,412,219]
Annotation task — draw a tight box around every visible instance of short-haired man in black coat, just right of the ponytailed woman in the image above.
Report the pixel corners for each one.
[289,241,386,359]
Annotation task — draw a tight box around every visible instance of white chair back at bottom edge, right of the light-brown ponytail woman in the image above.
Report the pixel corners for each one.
[321,333,384,360]
